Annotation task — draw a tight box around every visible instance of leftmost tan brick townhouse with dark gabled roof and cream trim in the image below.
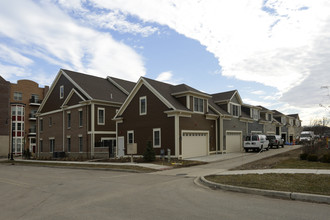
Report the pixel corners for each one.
[37,69,135,158]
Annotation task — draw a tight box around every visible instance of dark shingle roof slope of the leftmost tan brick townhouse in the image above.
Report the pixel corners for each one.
[62,69,127,103]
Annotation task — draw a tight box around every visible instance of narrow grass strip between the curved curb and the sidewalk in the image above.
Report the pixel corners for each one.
[205,174,330,196]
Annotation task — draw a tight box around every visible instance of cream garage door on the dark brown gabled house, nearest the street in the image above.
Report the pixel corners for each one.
[182,132,209,158]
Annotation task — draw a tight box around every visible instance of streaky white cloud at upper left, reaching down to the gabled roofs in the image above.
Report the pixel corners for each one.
[0,0,145,81]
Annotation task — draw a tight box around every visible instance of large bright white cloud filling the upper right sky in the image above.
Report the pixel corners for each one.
[87,0,330,91]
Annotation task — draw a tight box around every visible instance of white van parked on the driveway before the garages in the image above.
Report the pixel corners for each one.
[244,134,269,152]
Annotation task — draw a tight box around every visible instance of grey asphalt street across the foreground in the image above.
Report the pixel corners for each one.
[0,164,330,220]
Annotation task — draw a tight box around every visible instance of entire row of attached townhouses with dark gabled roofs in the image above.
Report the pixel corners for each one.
[37,69,302,158]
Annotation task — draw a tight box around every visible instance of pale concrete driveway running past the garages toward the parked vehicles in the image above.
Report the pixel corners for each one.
[153,145,302,177]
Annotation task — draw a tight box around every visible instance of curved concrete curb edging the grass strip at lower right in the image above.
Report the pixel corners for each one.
[199,176,330,204]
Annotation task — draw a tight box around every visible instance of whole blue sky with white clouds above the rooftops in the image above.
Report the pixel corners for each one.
[0,0,330,125]
